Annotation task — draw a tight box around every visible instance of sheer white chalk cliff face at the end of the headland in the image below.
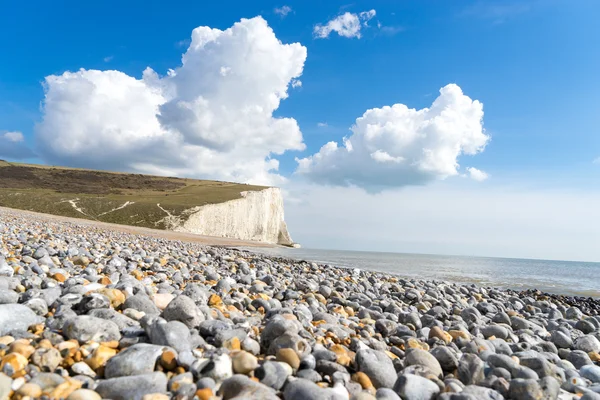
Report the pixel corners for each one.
[170,188,293,246]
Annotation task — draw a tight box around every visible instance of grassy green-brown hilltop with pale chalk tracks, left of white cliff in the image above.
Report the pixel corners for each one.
[0,160,265,229]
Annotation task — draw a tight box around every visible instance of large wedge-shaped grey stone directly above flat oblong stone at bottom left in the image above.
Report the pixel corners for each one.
[104,343,168,379]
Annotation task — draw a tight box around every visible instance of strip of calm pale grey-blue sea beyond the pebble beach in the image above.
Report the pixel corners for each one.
[241,247,600,298]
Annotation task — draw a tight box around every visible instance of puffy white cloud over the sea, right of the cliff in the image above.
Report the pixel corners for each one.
[296,84,489,191]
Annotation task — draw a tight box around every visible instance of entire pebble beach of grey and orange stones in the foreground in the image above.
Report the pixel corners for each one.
[0,209,600,400]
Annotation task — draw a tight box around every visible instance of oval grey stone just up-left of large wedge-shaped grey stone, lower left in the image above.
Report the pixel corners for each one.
[62,315,121,343]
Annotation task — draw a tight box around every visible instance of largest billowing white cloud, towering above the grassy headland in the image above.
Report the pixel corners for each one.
[36,17,306,184]
